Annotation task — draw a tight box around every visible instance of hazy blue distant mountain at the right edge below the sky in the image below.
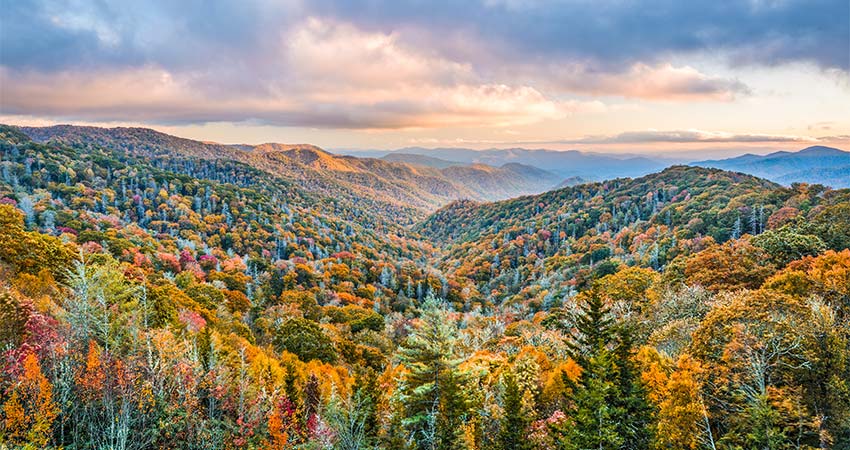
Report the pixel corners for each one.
[690,146,850,188]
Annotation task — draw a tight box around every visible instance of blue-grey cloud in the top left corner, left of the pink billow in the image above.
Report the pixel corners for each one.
[0,0,288,71]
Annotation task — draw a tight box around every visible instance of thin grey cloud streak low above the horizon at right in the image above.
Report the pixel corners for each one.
[553,130,818,144]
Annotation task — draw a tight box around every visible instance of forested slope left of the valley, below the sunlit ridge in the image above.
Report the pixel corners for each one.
[0,126,422,264]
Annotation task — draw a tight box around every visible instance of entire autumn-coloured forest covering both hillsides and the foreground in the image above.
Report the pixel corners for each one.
[0,127,850,450]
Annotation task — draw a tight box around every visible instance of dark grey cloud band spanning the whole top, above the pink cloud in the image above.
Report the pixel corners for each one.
[0,0,850,71]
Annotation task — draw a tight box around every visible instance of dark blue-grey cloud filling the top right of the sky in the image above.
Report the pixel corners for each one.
[313,0,850,72]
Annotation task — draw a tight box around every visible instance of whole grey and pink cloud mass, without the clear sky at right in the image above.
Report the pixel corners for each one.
[0,0,850,129]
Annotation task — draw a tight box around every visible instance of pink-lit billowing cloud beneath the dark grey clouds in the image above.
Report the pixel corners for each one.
[0,19,592,129]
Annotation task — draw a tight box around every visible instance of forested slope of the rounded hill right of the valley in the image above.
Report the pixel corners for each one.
[415,166,792,302]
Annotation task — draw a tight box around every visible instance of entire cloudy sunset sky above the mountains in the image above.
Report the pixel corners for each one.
[0,0,850,155]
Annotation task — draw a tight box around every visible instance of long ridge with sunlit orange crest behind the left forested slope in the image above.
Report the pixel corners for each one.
[13,125,561,222]
